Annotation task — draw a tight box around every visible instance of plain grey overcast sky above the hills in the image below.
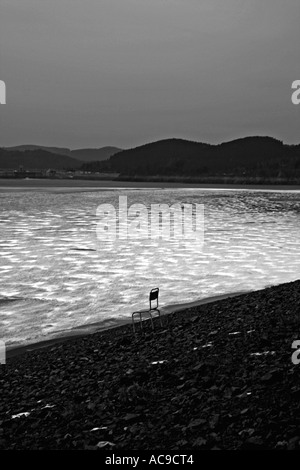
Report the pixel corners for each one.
[0,0,300,149]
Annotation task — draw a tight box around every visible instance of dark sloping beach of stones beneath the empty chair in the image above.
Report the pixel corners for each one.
[0,281,300,451]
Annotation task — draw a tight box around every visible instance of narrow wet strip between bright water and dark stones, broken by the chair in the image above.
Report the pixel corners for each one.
[6,291,251,359]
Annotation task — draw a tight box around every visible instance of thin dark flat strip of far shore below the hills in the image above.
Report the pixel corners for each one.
[0,178,300,192]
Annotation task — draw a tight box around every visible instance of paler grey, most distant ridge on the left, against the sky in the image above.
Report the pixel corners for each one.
[4,144,122,162]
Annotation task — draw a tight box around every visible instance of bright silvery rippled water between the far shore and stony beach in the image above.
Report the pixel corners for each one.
[0,188,300,344]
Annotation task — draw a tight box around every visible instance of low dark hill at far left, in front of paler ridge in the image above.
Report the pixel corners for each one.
[0,148,82,170]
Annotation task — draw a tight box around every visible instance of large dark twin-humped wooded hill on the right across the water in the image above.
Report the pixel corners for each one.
[82,137,300,177]
